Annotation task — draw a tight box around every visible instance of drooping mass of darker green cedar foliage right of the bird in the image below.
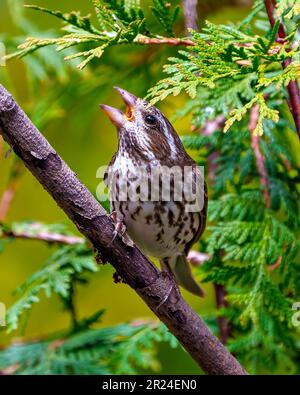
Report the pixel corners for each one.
[183,109,300,373]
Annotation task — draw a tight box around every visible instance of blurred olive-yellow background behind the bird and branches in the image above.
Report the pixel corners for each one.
[0,0,251,374]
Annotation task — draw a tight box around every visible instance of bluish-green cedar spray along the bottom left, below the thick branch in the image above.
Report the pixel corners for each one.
[0,310,177,375]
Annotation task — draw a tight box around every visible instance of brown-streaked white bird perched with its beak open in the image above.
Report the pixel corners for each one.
[100,87,207,296]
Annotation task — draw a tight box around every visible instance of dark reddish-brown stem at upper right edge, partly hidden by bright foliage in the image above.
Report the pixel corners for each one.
[264,0,300,139]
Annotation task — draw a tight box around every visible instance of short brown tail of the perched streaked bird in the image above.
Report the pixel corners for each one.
[160,255,205,297]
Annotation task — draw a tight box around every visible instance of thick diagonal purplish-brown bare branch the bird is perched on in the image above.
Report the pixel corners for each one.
[0,85,246,375]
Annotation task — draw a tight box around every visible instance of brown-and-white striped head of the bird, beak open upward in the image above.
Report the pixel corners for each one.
[100,87,187,162]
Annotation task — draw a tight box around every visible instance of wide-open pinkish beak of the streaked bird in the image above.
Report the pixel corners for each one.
[100,87,138,127]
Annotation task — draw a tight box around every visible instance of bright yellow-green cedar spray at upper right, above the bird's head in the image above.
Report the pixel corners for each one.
[149,14,300,135]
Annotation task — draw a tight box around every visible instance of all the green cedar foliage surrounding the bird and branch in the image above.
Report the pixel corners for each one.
[0,0,300,374]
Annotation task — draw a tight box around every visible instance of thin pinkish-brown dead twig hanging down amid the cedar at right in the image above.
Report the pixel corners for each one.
[248,104,270,207]
